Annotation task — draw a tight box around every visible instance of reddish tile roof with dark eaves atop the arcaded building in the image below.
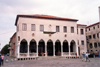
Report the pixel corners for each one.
[15,14,78,25]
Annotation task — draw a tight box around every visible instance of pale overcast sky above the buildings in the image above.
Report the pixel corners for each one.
[0,0,100,48]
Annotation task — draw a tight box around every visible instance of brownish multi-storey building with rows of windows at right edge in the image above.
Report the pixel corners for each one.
[86,22,100,53]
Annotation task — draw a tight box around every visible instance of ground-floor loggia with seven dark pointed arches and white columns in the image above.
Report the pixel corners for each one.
[18,39,78,57]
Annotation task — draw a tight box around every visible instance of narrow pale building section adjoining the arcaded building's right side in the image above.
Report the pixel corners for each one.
[77,24,87,55]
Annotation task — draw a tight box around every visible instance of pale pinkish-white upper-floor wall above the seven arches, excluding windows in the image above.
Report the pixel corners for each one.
[17,18,77,42]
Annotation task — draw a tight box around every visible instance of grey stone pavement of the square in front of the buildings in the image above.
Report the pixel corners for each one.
[1,58,100,67]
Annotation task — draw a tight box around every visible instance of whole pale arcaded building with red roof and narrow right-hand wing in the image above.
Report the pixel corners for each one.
[9,15,87,58]
